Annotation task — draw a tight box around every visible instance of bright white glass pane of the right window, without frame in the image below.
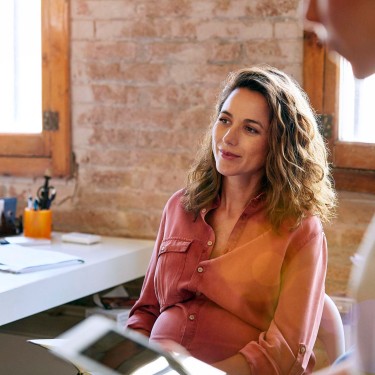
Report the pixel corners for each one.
[339,59,375,143]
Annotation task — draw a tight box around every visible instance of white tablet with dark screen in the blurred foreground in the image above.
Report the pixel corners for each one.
[52,315,225,375]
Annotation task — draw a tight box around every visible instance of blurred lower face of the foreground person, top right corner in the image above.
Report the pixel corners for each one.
[303,0,375,78]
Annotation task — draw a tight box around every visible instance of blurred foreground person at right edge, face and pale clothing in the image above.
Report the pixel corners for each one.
[302,0,375,374]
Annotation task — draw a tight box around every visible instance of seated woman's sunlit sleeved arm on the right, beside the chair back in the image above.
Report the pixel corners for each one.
[240,222,327,375]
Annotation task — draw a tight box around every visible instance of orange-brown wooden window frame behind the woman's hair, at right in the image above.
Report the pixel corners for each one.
[303,32,375,193]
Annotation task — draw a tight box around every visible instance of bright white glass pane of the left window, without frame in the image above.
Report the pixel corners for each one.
[0,0,42,134]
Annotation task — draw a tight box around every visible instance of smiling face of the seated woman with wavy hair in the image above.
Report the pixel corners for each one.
[212,88,270,188]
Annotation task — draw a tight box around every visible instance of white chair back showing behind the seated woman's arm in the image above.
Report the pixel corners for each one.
[318,294,345,364]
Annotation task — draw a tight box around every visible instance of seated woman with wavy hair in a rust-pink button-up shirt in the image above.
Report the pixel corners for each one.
[127,66,335,375]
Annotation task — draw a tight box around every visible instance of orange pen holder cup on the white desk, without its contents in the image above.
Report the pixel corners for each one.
[23,208,52,238]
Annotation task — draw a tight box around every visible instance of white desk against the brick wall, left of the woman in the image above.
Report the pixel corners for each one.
[0,233,154,325]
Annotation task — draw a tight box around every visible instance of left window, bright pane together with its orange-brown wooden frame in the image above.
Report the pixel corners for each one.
[0,0,72,177]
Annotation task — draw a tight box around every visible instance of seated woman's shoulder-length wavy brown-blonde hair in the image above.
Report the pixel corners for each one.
[182,65,337,230]
